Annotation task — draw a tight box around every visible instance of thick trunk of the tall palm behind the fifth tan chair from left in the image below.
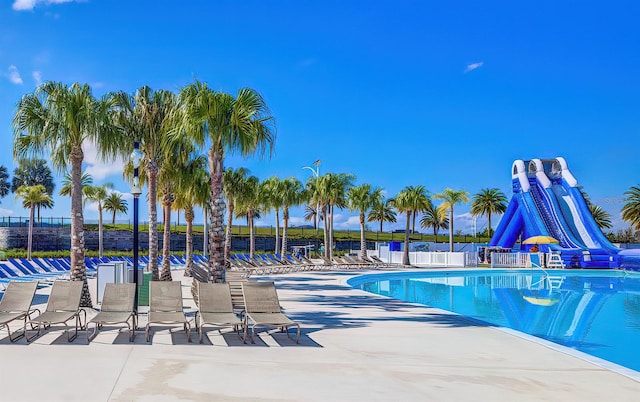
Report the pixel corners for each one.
[208,147,225,283]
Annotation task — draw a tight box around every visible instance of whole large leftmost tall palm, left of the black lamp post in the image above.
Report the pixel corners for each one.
[13,82,120,307]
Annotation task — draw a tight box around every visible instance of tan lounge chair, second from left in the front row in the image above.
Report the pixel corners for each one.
[24,281,87,342]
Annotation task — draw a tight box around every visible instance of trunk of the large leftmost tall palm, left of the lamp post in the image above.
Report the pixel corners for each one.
[70,146,93,308]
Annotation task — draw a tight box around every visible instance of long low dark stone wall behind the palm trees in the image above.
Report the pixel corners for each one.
[0,227,375,251]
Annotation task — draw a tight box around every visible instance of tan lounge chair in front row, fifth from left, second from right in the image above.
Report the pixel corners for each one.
[195,282,242,343]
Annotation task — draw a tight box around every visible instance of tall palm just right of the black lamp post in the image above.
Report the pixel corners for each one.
[110,86,176,281]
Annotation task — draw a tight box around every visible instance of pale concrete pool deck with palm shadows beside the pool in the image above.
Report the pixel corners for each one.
[0,271,640,401]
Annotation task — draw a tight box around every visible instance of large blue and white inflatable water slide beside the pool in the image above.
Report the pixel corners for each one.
[489,158,620,268]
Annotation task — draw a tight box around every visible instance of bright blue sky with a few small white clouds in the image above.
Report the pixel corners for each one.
[0,0,640,233]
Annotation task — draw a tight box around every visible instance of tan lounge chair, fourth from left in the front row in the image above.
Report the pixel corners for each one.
[145,281,191,342]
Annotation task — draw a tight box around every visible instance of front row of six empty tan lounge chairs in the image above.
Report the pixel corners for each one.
[0,281,300,343]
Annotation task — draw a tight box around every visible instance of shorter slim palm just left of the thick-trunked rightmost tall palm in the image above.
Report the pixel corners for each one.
[174,155,209,276]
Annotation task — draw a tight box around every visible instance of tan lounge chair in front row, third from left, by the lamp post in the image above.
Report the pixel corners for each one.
[86,283,137,342]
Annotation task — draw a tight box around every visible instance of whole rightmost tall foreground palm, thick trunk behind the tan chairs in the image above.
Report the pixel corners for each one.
[179,81,275,282]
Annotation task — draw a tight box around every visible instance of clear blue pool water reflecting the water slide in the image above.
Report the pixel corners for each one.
[349,270,640,371]
